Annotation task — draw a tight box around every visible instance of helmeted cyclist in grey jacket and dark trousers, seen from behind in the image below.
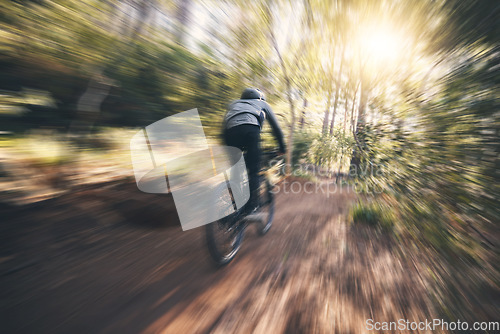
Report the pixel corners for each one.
[223,88,285,214]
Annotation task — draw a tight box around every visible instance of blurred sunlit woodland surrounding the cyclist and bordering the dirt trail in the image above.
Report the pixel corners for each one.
[0,0,500,332]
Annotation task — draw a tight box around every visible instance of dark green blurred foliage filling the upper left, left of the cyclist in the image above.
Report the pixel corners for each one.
[0,0,246,136]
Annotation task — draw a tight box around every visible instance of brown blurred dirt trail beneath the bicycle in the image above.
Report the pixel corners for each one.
[0,183,432,333]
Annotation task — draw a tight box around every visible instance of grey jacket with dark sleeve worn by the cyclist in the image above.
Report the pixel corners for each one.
[224,99,285,152]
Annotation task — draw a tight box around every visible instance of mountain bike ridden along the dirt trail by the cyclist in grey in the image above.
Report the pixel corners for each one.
[205,151,284,266]
